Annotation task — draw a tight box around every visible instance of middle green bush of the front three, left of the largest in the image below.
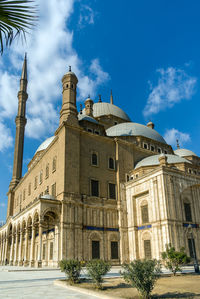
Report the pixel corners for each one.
[86,260,111,289]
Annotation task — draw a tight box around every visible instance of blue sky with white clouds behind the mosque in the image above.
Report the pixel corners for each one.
[0,0,200,221]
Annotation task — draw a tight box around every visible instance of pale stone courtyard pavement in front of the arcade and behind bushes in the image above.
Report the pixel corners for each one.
[0,266,194,299]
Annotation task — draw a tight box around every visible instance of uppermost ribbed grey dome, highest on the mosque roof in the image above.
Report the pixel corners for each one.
[83,102,130,121]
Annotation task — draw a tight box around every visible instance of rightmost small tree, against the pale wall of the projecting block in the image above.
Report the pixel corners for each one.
[162,244,190,276]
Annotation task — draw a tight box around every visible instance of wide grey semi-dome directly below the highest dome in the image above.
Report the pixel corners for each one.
[106,122,166,143]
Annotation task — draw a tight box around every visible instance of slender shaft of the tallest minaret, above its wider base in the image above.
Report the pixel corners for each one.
[10,54,28,187]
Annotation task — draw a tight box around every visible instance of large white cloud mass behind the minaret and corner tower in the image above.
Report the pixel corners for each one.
[0,0,109,149]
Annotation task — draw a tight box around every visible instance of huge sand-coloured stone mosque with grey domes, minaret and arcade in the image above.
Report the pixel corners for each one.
[0,57,200,267]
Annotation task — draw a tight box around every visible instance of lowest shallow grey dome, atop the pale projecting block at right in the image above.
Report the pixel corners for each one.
[135,154,191,169]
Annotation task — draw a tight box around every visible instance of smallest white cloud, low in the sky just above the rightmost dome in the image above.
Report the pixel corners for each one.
[164,128,191,147]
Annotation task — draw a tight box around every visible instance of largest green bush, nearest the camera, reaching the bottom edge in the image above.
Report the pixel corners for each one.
[120,260,160,298]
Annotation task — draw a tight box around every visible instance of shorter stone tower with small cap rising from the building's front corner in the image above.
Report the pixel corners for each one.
[60,66,78,125]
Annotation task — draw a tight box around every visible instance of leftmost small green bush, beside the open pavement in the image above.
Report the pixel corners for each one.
[59,259,82,284]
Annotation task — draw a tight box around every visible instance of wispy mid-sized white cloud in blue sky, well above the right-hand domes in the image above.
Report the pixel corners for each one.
[143,67,197,117]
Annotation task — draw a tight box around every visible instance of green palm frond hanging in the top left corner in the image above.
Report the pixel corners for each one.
[0,0,38,54]
